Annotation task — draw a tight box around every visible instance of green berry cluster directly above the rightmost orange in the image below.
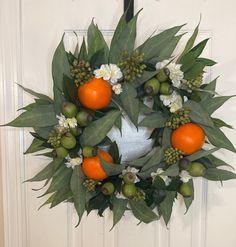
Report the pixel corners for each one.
[166,108,191,129]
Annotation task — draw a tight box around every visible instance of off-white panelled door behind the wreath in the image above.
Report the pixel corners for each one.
[0,0,236,247]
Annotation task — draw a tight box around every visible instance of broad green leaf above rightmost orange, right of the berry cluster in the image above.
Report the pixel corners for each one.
[184,100,214,127]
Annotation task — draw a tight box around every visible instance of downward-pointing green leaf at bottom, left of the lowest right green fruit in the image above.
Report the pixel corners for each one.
[159,191,176,225]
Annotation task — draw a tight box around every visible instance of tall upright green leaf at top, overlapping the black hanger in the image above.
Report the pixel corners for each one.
[109,11,140,63]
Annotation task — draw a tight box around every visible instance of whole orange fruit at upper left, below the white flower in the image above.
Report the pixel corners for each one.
[78,77,112,110]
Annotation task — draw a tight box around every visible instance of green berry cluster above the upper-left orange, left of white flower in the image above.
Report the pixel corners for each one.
[70,59,93,87]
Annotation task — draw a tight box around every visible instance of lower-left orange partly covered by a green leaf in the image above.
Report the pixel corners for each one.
[82,150,113,180]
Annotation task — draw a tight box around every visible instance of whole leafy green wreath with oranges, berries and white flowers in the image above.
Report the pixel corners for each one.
[2,11,236,226]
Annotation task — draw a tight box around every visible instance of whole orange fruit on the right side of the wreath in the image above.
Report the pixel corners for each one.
[171,123,205,155]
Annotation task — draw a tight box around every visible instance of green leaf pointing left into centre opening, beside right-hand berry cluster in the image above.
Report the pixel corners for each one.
[139,112,167,128]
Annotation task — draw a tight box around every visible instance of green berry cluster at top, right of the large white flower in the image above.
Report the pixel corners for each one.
[118,50,146,82]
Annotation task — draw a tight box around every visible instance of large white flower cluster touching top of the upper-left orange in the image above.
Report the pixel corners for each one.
[94,64,123,85]
